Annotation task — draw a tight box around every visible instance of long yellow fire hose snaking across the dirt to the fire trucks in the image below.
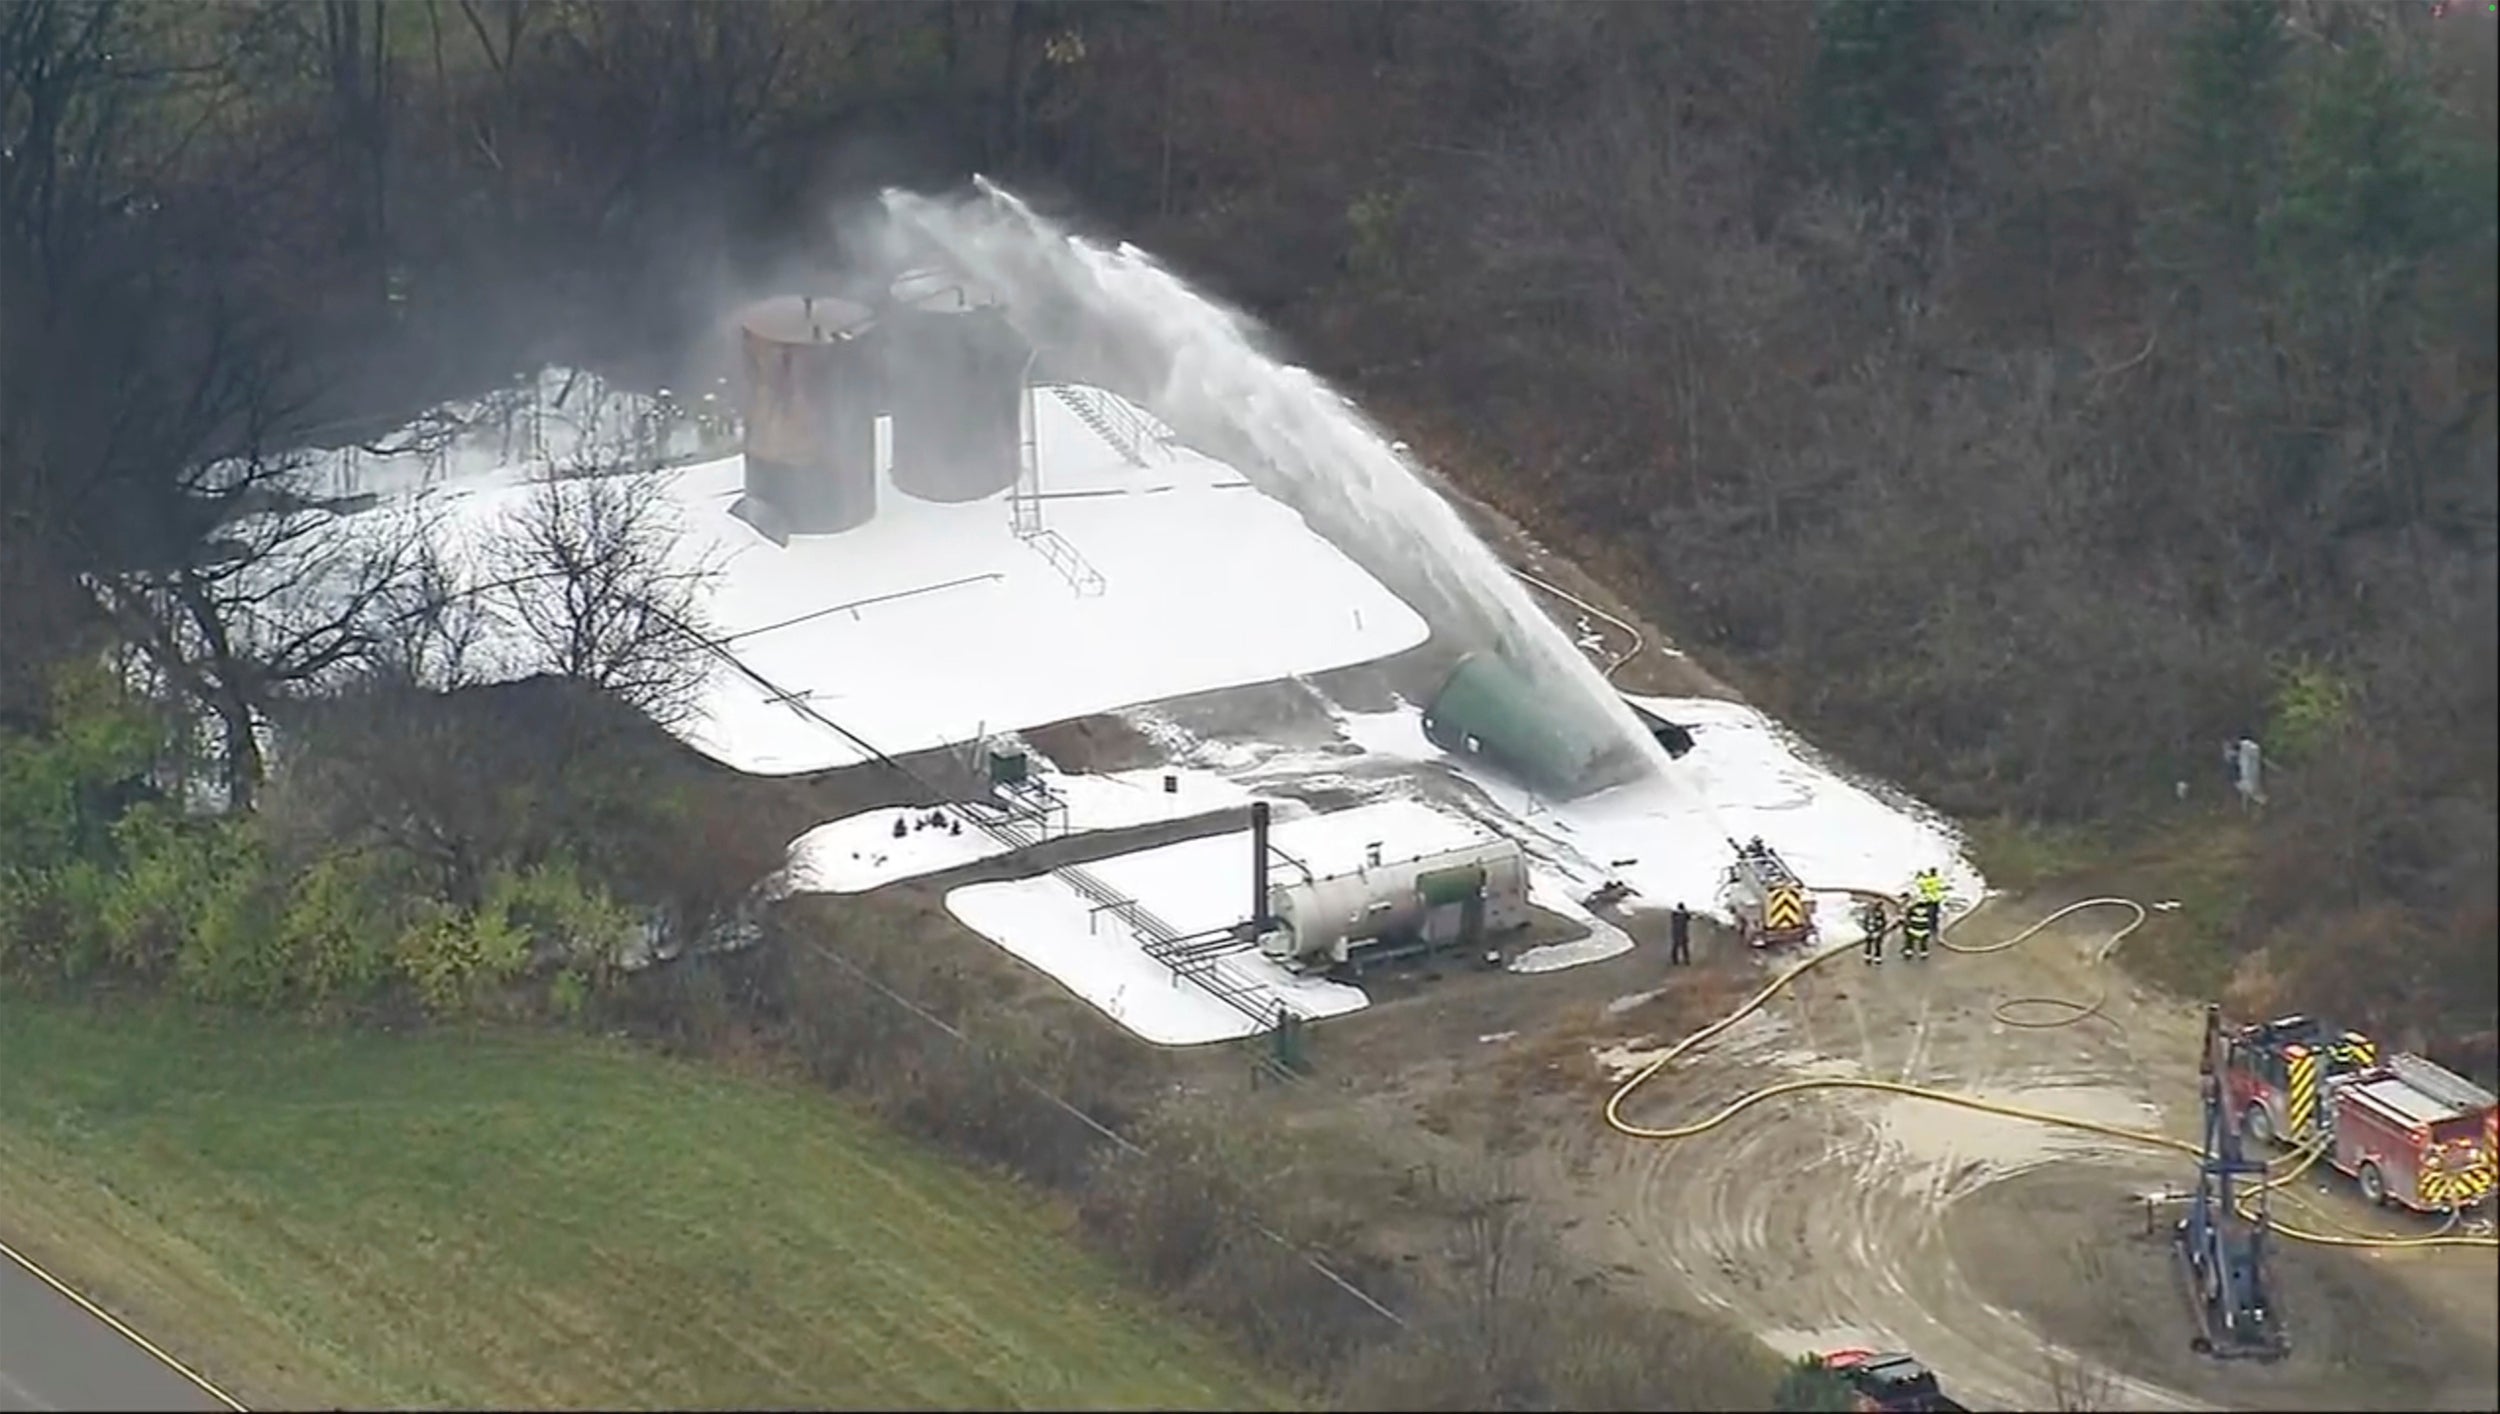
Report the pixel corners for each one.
[1605,889,2500,1249]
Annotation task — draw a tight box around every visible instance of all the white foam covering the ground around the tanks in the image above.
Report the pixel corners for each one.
[273,364,1983,1042]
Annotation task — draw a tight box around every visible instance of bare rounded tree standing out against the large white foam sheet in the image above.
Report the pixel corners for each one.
[493,465,715,724]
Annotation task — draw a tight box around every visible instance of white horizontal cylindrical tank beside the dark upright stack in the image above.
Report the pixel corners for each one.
[1263,837,1528,969]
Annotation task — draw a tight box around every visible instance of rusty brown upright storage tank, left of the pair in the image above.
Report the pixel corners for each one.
[738,295,883,535]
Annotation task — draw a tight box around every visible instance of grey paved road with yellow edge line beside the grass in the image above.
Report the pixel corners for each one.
[0,1252,225,1412]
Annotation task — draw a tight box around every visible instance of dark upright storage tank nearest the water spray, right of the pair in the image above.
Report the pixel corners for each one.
[883,270,1030,502]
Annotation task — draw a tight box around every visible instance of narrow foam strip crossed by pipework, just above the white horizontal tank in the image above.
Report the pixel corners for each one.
[790,767,1260,894]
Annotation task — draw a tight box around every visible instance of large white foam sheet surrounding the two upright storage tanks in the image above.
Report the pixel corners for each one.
[302,382,1428,774]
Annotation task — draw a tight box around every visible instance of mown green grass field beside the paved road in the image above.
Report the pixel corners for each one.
[0,997,1278,1409]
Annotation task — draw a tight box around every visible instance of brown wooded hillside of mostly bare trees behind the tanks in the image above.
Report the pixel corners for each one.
[0,0,2500,1064]
